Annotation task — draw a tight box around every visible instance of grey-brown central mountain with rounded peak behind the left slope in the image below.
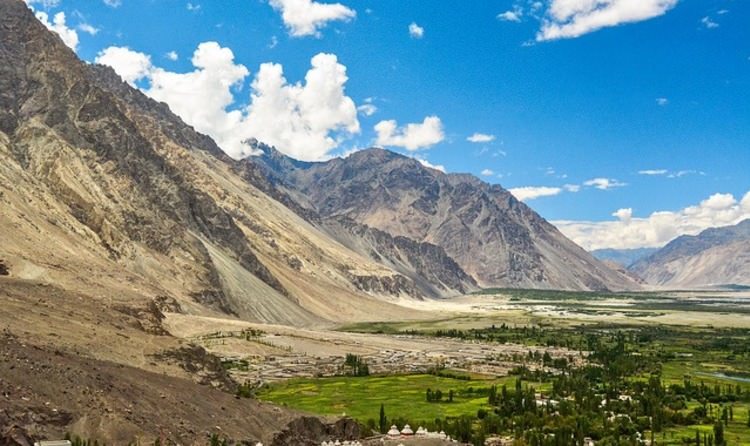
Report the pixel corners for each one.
[248,145,637,290]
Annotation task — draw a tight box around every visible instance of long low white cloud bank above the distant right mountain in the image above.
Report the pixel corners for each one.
[552,191,750,250]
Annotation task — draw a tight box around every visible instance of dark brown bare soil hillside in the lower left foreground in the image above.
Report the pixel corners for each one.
[0,278,306,445]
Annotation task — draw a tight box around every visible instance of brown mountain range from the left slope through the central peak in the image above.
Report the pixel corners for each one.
[0,0,635,334]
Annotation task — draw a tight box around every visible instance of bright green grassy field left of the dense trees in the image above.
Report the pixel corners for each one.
[258,375,546,422]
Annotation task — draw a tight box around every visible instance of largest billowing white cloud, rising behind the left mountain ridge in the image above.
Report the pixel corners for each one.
[96,42,360,160]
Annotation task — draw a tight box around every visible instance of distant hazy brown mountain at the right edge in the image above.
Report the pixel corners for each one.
[629,219,750,287]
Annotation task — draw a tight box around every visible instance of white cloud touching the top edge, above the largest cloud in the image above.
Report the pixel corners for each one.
[269,0,357,37]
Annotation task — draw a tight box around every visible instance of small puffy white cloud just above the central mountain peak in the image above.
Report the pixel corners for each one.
[375,116,445,151]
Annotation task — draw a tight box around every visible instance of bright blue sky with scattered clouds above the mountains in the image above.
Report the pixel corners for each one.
[23,0,750,248]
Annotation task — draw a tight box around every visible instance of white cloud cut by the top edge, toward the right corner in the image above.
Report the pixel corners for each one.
[536,0,678,41]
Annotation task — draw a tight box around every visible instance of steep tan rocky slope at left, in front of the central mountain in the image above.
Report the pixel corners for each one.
[0,0,482,332]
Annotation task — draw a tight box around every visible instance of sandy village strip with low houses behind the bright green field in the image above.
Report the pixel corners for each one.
[184,326,585,386]
